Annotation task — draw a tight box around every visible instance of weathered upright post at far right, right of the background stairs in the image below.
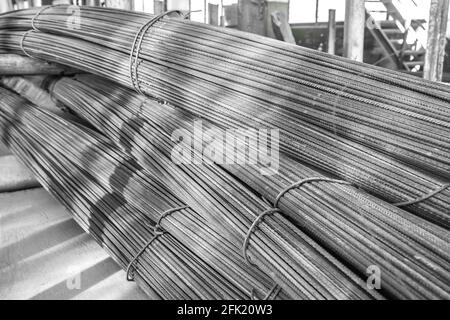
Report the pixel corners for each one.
[423,0,450,81]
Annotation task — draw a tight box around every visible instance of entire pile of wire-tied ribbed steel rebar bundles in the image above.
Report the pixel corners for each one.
[0,6,450,299]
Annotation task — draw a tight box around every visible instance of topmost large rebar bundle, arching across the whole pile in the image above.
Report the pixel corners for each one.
[0,6,450,228]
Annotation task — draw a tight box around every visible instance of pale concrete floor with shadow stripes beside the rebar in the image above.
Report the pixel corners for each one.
[0,188,147,299]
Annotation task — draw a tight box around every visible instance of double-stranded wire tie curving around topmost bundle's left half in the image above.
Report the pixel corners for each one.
[130,10,183,94]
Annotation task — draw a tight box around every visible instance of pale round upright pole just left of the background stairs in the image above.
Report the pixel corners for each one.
[344,0,366,62]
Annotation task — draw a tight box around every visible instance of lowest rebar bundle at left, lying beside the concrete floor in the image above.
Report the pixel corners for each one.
[0,88,290,299]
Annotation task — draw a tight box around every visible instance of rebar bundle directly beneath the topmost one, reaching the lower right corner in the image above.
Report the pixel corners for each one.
[45,76,450,298]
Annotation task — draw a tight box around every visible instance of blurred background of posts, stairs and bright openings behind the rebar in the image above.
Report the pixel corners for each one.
[0,0,450,81]
